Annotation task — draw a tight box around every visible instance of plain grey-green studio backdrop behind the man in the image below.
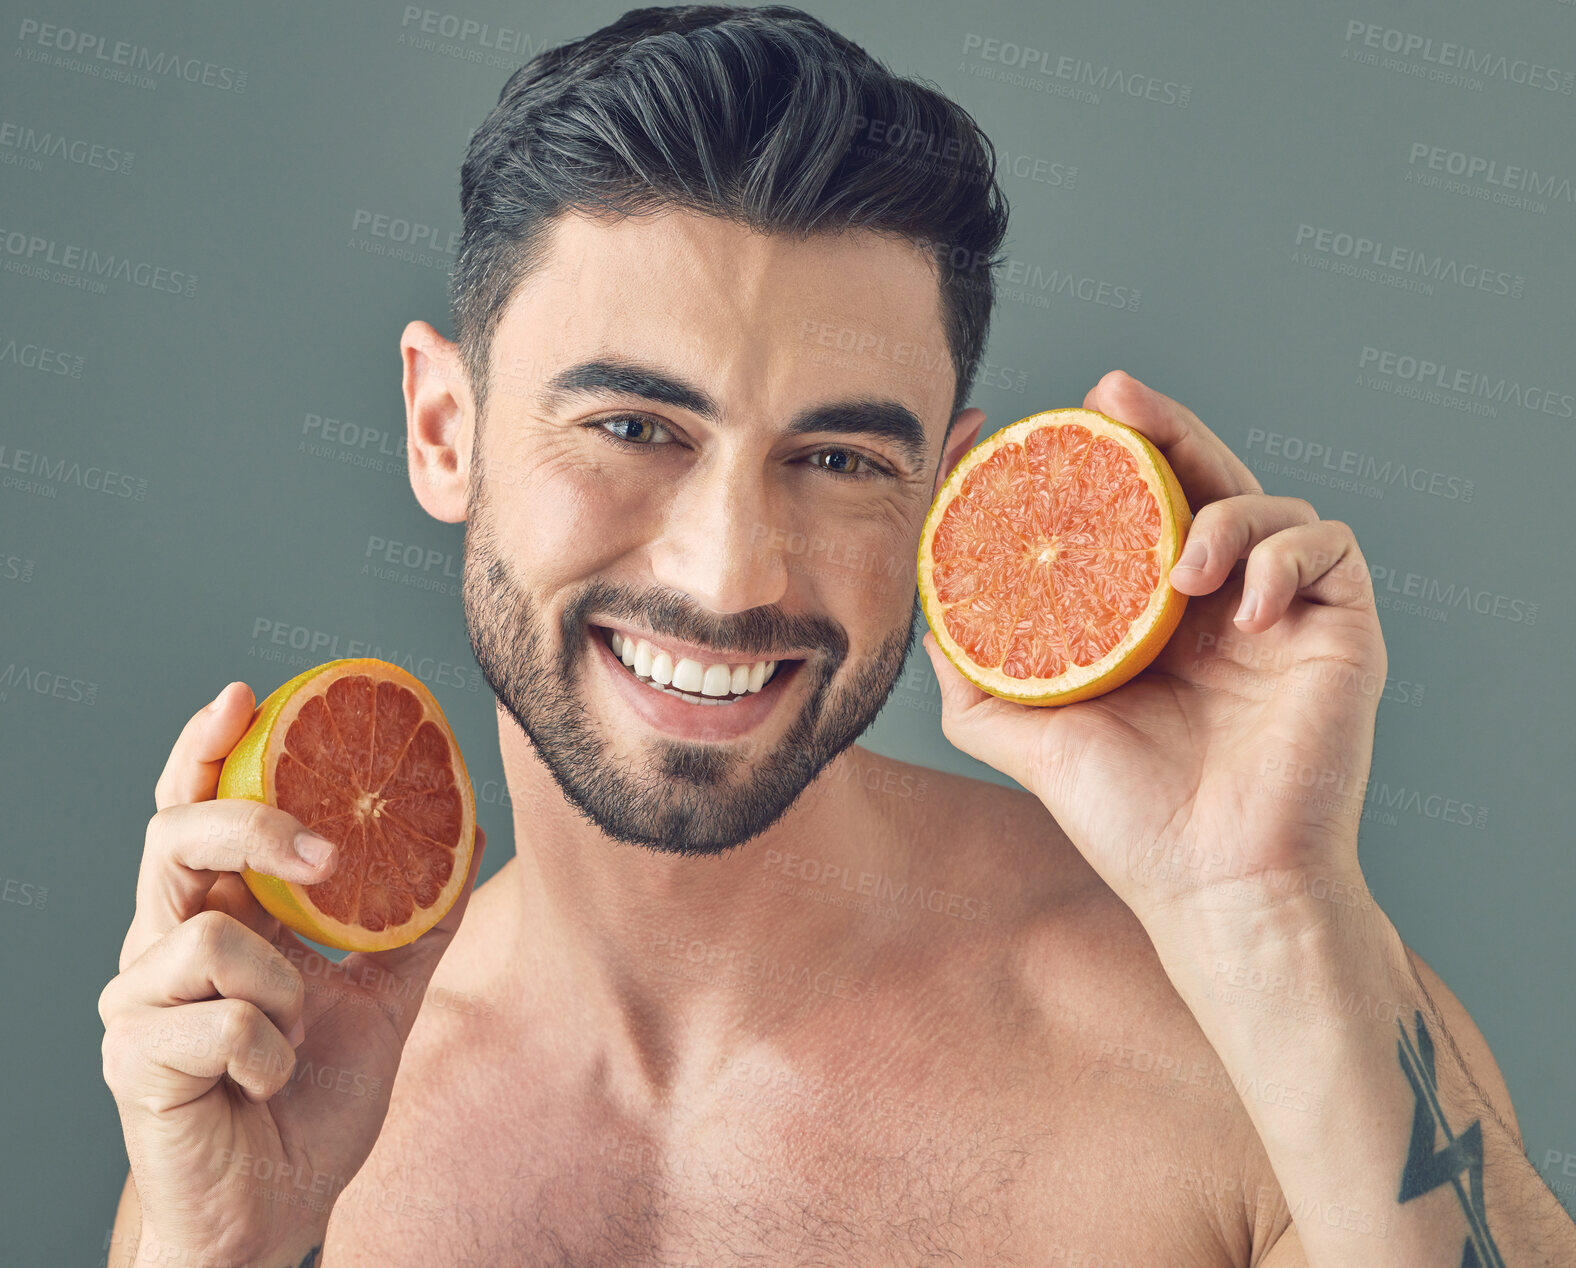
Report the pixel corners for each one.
[0,0,1576,1265]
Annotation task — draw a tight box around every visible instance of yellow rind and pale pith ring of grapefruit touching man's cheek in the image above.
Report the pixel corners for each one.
[919,408,1193,706]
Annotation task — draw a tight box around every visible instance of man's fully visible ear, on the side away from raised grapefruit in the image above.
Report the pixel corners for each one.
[399,321,476,525]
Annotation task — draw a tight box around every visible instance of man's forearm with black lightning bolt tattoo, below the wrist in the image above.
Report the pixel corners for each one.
[1157,896,1576,1268]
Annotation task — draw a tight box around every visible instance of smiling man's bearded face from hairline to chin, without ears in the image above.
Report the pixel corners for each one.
[463,213,955,854]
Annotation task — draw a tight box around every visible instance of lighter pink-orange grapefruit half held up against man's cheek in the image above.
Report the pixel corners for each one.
[919,410,1193,704]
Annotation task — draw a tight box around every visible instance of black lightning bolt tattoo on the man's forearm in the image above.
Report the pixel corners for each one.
[1396,1010,1505,1268]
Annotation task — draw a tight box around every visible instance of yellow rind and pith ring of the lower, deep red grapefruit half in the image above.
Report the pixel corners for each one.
[216,657,476,951]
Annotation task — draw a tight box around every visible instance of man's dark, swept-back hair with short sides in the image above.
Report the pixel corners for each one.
[449,5,1007,427]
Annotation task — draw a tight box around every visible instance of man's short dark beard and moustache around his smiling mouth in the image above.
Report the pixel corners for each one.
[462,447,922,855]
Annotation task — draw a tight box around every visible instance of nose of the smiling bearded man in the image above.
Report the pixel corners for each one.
[651,457,788,613]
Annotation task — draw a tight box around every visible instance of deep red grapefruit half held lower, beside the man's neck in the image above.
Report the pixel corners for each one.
[217,658,476,951]
